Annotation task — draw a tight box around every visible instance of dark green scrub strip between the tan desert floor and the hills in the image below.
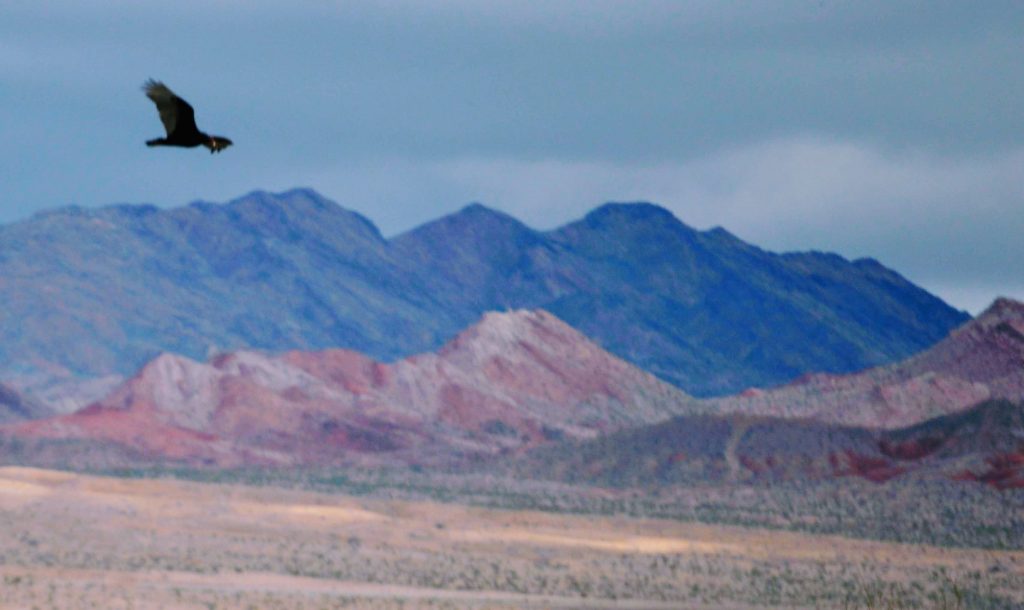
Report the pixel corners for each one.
[70,468,1024,550]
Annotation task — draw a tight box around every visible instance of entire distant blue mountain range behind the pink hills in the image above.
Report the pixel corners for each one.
[0,189,967,409]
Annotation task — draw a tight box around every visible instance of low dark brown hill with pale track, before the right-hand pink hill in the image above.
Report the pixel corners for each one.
[516,401,1024,489]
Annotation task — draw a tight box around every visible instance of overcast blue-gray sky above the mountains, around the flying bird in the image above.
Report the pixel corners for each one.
[0,0,1024,313]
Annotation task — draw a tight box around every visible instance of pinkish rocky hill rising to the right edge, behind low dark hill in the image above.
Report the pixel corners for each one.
[709,299,1024,429]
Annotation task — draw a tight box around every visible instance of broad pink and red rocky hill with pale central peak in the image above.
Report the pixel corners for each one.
[0,310,697,466]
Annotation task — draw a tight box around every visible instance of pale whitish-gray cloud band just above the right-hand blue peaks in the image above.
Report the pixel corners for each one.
[294,137,1024,312]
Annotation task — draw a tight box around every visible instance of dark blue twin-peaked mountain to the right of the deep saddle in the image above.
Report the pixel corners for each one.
[392,204,968,396]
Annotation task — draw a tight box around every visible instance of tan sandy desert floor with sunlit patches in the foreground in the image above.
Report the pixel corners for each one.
[0,468,1024,609]
